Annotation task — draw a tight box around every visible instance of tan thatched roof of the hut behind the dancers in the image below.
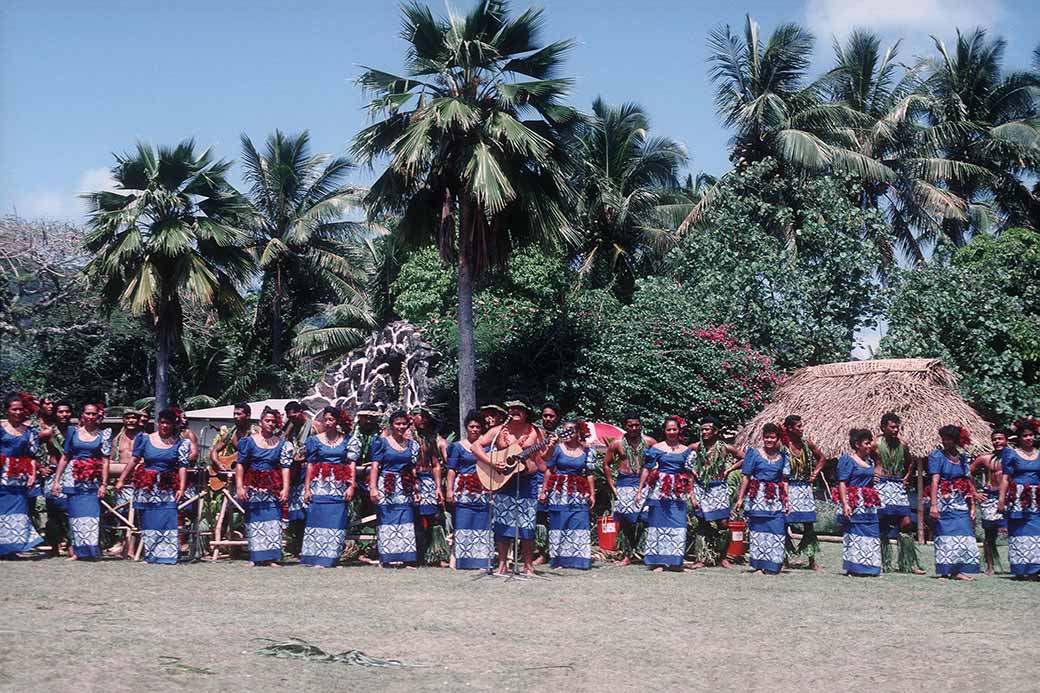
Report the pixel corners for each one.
[736,359,991,458]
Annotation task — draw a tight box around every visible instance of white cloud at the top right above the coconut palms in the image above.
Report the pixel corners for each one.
[805,0,1004,44]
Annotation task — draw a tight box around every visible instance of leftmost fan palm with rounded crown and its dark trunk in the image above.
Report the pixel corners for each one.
[83,139,255,409]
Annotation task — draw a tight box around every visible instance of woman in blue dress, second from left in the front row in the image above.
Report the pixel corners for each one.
[51,404,112,561]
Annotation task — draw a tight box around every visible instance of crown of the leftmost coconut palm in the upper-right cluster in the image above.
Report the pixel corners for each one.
[679,15,893,233]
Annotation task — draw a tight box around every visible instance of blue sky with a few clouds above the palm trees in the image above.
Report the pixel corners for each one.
[0,0,1040,221]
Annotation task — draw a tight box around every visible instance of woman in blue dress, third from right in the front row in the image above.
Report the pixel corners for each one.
[833,429,882,576]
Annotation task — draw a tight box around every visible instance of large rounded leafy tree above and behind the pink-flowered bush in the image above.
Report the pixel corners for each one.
[666,159,887,368]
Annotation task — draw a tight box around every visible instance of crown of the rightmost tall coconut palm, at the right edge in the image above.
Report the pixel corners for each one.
[928,28,1040,245]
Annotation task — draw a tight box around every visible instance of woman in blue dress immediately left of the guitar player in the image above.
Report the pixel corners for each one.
[447,410,495,570]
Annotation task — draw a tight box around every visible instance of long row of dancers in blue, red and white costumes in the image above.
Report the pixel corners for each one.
[0,395,1040,580]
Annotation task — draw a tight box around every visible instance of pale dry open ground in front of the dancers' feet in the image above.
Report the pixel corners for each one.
[0,544,1040,691]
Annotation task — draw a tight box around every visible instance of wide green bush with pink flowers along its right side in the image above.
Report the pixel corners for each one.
[569,279,776,425]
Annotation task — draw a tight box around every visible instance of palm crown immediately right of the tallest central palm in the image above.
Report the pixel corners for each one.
[578,98,686,303]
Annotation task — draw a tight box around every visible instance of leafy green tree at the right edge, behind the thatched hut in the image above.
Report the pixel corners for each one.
[881,228,1040,424]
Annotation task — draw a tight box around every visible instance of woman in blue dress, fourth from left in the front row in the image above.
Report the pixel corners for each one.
[235,407,293,567]
